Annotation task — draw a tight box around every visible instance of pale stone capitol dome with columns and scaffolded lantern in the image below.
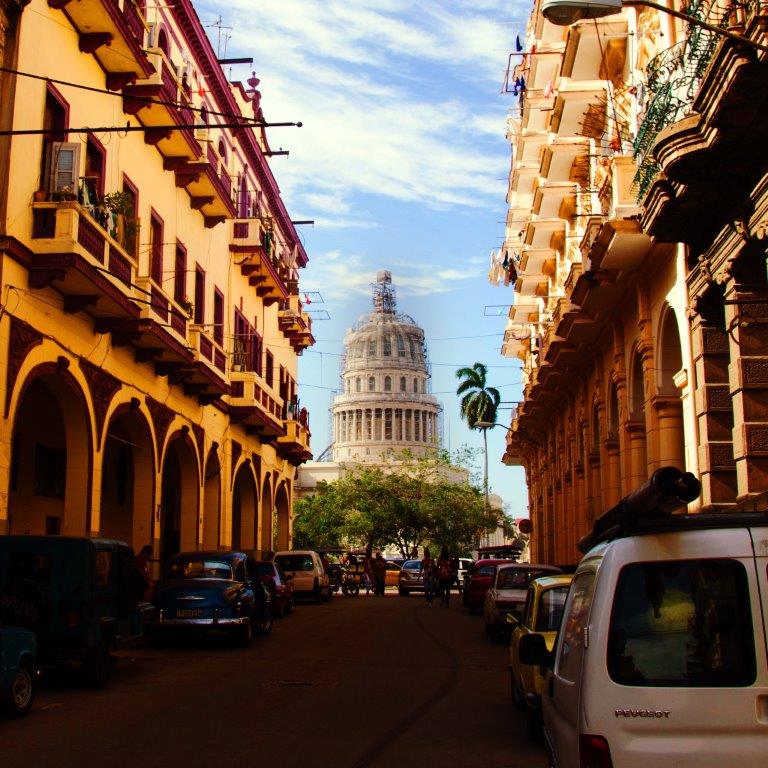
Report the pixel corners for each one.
[332,271,442,462]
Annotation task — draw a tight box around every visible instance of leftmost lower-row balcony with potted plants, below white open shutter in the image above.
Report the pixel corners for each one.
[29,200,139,319]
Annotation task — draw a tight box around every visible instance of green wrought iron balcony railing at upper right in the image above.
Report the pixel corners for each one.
[633,0,736,200]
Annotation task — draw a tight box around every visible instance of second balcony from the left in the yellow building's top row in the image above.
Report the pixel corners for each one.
[123,48,202,162]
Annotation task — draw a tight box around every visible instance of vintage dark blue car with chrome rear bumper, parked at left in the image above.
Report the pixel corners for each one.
[147,552,272,646]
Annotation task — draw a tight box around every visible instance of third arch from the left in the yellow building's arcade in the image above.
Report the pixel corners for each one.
[160,428,200,561]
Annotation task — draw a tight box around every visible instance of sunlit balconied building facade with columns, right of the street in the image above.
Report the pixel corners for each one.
[496,2,768,565]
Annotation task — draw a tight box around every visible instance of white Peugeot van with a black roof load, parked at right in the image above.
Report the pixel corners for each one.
[520,467,768,768]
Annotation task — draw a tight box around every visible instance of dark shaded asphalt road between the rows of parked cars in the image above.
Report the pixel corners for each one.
[0,594,546,768]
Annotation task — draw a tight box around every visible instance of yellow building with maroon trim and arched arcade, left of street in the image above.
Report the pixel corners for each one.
[0,0,314,560]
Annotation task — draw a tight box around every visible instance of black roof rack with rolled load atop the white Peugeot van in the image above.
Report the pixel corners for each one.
[578,467,768,554]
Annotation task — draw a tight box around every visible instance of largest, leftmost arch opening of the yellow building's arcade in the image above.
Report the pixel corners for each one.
[8,358,94,536]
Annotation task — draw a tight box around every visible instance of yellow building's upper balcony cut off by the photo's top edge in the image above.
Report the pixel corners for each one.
[48,0,152,85]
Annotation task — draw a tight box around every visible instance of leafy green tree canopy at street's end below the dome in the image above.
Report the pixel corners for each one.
[293,458,502,557]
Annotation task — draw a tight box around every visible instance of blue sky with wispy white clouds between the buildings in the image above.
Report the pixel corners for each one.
[197,0,530,517]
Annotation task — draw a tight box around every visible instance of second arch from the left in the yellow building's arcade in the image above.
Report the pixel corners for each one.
[98,401,156,551]
